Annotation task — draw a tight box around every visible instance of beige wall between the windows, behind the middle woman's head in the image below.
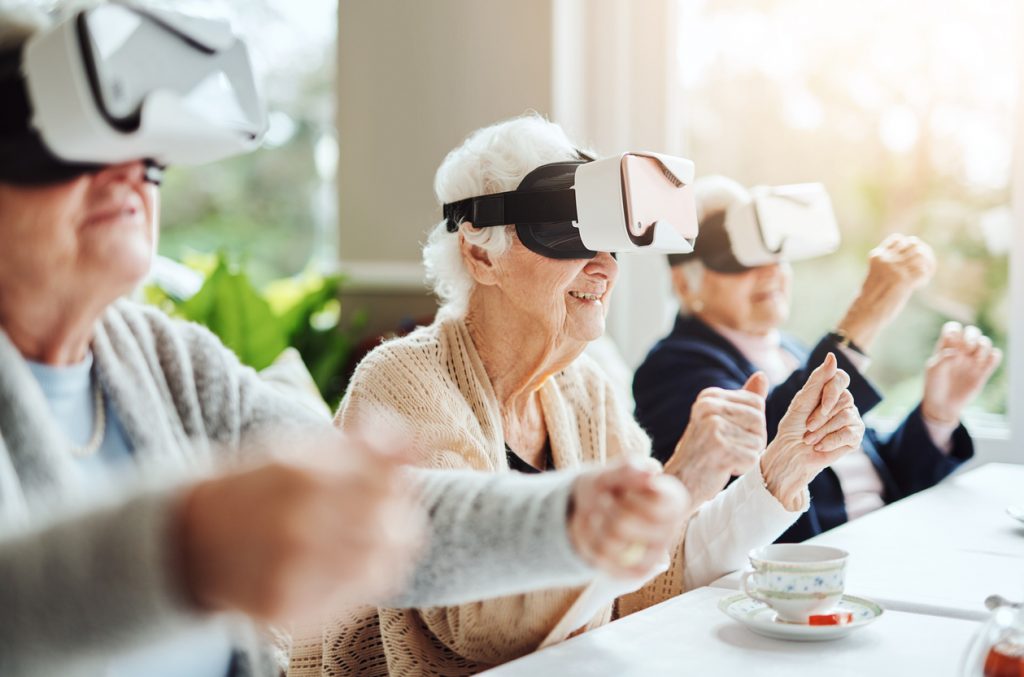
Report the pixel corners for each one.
[338,0,552,282]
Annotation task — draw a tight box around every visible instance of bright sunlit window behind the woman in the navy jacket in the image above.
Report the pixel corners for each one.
[679,0,1024,423]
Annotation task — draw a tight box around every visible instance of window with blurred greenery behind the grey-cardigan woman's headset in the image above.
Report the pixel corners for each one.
[160,0,337,283]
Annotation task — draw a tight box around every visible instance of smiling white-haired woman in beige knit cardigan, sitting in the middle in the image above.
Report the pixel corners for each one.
[336,115,863,675]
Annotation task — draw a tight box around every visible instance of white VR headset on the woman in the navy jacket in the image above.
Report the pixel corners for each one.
[669,183,841,272]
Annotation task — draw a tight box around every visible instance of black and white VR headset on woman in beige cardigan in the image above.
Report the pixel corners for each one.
[443,153,697,259]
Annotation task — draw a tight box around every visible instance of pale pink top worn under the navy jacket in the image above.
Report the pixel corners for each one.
[709,323,956,519]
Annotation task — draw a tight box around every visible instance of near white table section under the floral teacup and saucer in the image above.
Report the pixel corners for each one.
[486,588,979,677]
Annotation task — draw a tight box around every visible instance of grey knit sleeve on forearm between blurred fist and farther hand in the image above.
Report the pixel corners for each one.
[388,470,595,606]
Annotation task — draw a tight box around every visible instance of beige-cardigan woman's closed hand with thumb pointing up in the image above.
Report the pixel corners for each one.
[665,372,768,505]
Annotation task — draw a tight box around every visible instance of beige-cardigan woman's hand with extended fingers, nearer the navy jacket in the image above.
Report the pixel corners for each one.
[761,353,864,510]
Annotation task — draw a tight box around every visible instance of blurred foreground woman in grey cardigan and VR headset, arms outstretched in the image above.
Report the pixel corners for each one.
[0,3,704,676]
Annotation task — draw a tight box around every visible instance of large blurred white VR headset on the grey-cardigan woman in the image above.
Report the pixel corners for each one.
[0,2,266,184]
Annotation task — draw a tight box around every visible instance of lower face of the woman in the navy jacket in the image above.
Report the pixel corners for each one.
[697,263,793,335]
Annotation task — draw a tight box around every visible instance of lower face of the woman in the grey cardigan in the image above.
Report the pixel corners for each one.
[0,162,158,302]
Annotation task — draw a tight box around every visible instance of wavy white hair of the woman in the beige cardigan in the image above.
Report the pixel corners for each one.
[423,113,589,318]
